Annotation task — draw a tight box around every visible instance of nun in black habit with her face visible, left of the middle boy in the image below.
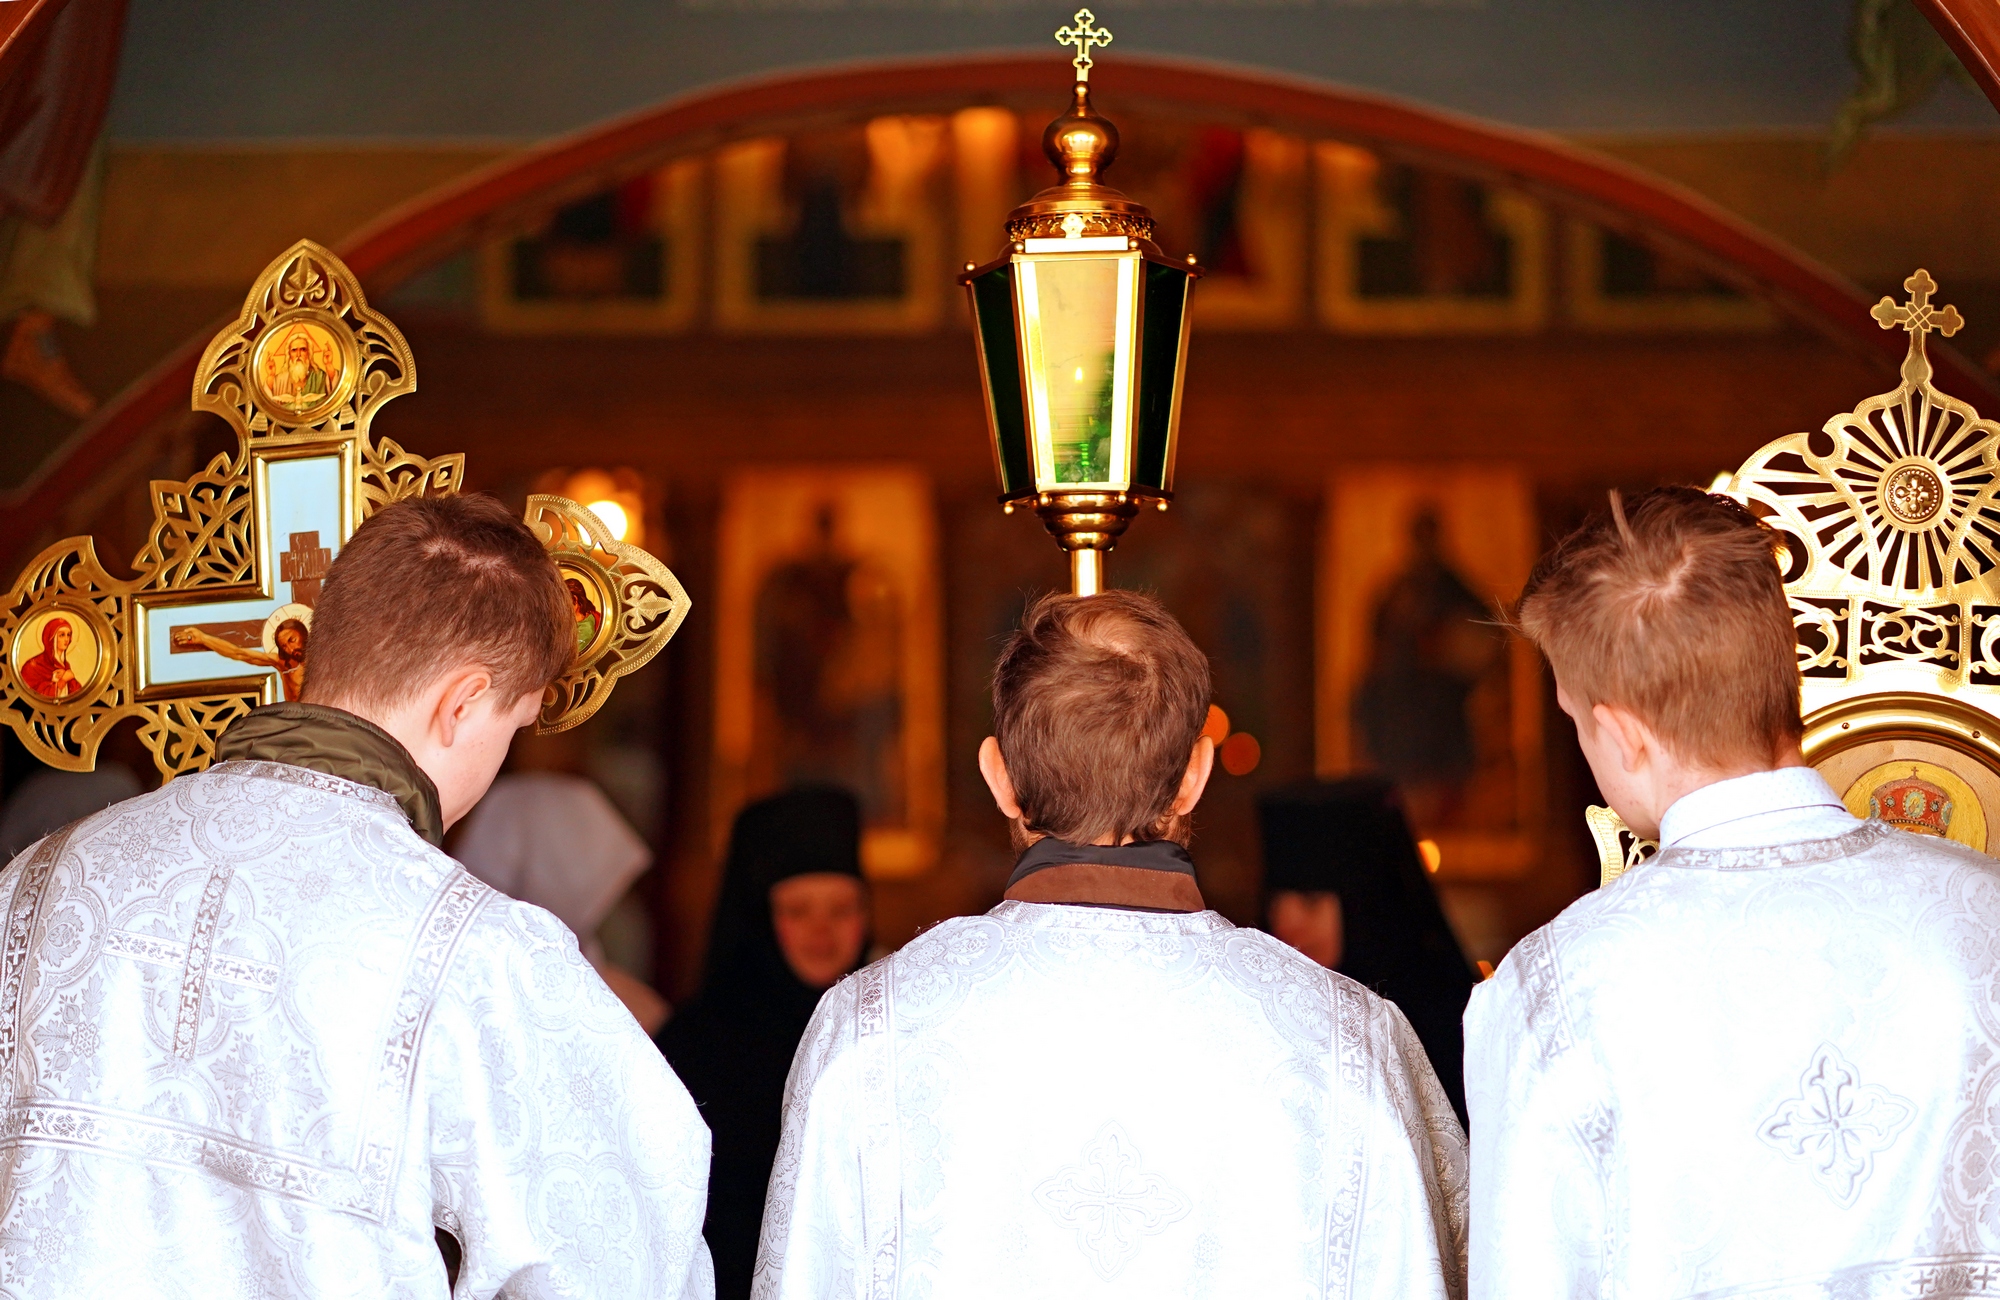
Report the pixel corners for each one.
[656,786,868,1300]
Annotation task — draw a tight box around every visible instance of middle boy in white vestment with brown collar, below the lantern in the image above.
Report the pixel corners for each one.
[752,592,1464,1300]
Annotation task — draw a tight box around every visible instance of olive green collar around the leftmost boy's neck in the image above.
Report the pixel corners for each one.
[216,702,444,846]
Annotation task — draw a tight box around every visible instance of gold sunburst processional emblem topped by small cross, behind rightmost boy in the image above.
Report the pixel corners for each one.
[1590,270,2000,884]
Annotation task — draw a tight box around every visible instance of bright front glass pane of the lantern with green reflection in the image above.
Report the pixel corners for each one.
[1034,258,1122,486]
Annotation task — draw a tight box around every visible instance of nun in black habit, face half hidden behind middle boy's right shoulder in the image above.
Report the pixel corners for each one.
[1258,776,1476,1124]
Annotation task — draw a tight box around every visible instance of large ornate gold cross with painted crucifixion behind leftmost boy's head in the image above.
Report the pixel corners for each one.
[0,240,688,776]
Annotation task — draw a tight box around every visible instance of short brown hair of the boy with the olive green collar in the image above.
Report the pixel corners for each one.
[306,496,576,708]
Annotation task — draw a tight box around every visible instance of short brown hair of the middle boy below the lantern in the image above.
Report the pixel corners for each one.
[994,592,1208,844]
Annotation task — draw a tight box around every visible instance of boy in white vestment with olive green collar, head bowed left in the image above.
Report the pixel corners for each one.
[0,498,710,1300]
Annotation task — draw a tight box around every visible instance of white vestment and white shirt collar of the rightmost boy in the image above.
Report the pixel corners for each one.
[1466,770,2000,1300]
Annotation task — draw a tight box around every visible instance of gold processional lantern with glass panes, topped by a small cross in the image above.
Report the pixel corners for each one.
[958,10,1200,596]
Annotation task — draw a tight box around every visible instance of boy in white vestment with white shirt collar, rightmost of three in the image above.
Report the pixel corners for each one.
[1466,488,2000,1300]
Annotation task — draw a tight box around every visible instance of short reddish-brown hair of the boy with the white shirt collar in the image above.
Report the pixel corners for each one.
[1516,488,1804,766]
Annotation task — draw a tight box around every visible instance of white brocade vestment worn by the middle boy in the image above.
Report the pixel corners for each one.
[752,902,1464,1300]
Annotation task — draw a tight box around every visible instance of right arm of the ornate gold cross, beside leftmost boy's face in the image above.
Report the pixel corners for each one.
[528,496,692,734]
